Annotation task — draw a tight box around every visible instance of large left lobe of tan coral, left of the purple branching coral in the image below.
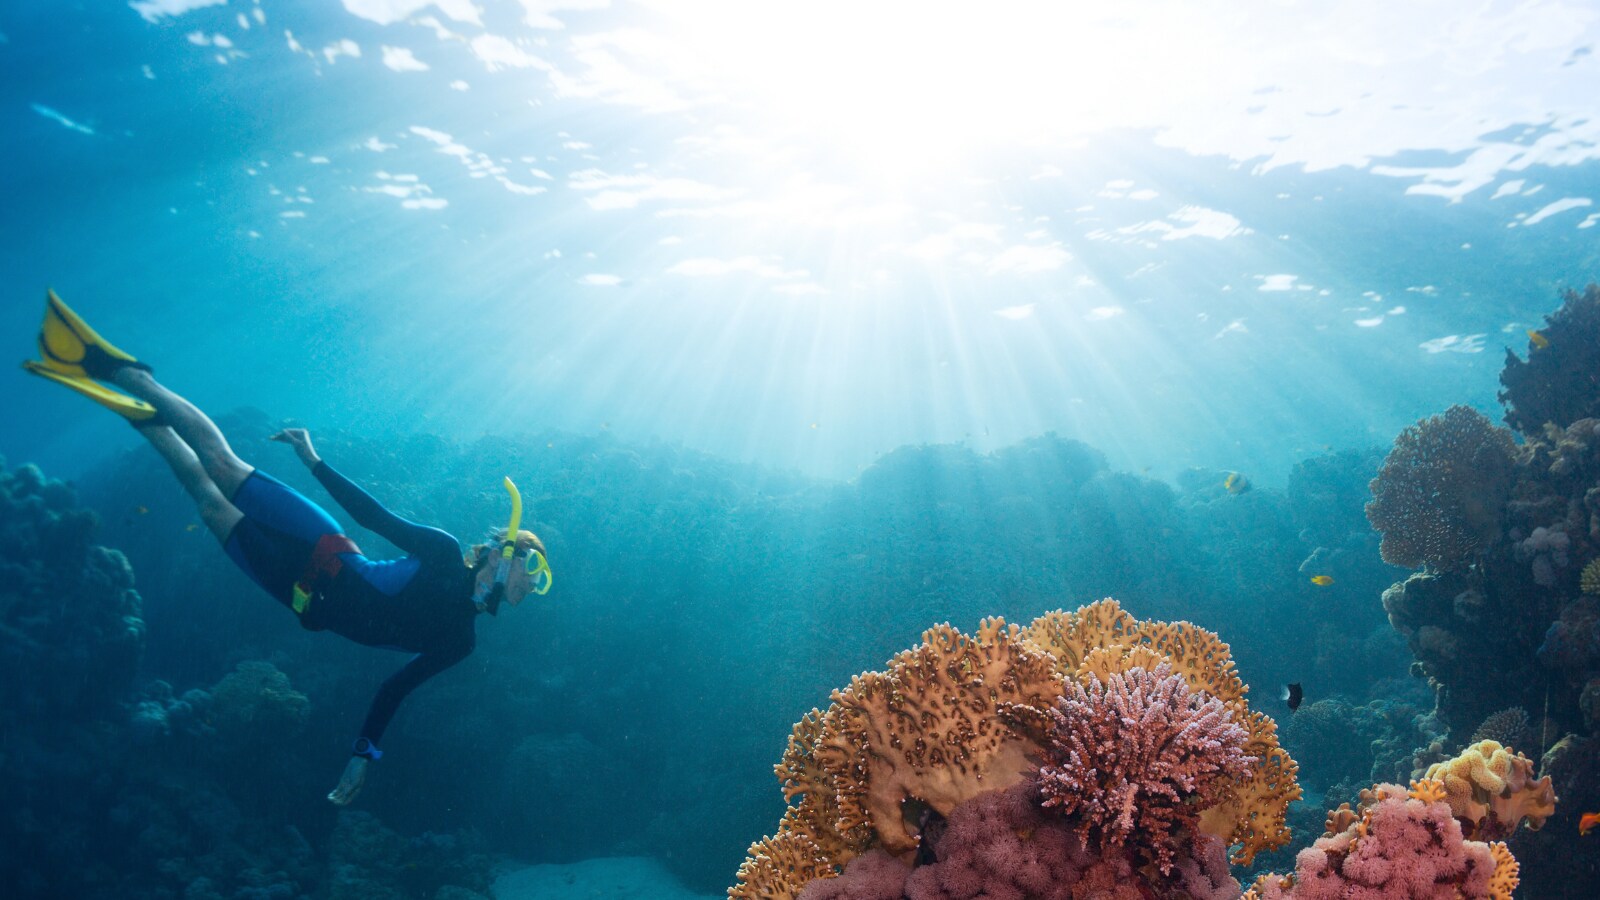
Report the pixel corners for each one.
[748,618,1062,898]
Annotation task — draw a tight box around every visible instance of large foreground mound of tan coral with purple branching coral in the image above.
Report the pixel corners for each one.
[730,601,1298,900]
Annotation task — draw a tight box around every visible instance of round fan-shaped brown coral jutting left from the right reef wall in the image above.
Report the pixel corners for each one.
[1366,407,1515,572]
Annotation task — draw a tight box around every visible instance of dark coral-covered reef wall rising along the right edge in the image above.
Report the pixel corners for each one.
[1368,285,1600,895]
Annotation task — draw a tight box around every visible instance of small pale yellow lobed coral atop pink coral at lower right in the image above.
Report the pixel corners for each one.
[1427,740,1555,839]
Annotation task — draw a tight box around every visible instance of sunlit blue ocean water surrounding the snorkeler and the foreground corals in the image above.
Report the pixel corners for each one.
[0,0,1600,900]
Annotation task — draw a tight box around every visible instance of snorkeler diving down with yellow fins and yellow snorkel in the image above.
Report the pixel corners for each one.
[22,291,552,806]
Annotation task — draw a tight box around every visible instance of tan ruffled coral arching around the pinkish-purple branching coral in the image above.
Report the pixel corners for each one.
[728,599,1299,900]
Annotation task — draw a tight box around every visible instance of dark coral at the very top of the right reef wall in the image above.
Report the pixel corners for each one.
[1499,285,1600,434]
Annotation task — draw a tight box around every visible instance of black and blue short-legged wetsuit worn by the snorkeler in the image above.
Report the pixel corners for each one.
[224,463,477,746]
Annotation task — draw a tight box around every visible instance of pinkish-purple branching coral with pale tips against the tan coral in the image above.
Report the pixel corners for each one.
[1038,663,1254,873]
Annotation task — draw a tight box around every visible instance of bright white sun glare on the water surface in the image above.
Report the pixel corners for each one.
[643,0,1221,176]
